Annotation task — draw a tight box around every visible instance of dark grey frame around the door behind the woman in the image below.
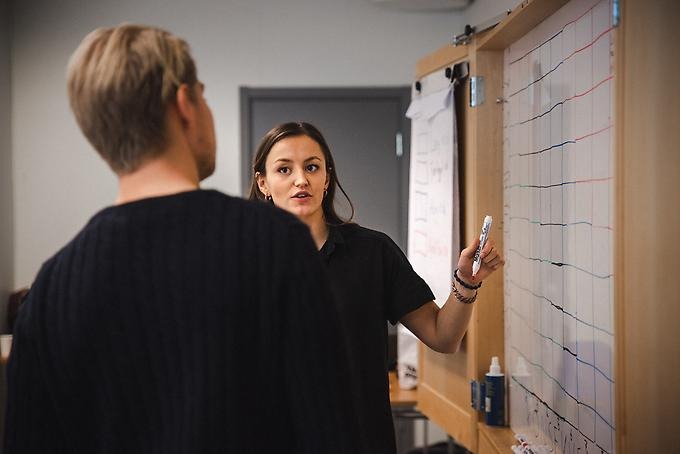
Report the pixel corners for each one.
[239,86,411,248]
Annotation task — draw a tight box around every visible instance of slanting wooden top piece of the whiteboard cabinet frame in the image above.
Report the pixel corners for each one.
[478,0,568,50]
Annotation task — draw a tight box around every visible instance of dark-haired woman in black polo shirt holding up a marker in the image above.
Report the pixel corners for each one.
[250,123,504,453]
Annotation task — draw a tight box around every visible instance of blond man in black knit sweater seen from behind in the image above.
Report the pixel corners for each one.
[4,25,361,454]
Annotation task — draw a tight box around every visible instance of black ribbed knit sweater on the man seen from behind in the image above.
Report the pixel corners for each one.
[5,190,361,454]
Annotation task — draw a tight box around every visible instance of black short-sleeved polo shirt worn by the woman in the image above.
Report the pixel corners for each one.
[321,224,434,454]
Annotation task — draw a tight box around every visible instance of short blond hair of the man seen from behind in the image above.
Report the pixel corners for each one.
[67,24,197,174]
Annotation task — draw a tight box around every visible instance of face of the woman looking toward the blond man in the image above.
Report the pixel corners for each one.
[257,135,328,222]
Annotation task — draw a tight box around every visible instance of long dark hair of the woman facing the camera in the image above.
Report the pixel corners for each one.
[248,122,354,225]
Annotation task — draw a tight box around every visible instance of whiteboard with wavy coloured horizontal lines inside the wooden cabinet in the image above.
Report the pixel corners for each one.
[503,0,616,453]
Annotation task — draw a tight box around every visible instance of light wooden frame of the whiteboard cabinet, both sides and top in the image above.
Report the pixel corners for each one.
[417,0,680,454]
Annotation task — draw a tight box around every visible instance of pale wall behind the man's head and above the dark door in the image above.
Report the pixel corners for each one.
[12,0,464,286]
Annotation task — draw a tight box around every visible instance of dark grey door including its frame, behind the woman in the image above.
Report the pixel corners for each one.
[241,87,411,252]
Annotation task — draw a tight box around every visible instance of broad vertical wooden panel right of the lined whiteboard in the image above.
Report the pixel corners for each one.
[615,0,680,453]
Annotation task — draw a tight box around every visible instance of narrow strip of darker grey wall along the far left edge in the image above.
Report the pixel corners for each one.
[0,0,14,332]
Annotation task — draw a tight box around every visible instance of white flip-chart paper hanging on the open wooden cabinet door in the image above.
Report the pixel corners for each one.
[406,69,460,307]
